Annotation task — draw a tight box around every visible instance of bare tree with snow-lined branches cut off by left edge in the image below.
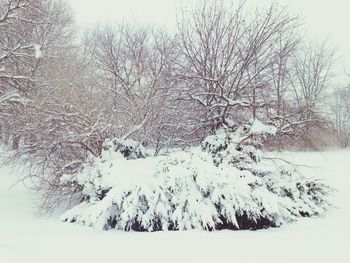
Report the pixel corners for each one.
[0,0,71,148]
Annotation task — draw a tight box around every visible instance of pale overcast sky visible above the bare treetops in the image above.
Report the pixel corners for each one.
[68,0,350,83]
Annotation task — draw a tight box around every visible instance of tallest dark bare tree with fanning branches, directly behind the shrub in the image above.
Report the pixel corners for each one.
[179,1,297,136]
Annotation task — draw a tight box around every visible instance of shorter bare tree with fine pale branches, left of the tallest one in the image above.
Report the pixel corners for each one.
[88,25,182,151]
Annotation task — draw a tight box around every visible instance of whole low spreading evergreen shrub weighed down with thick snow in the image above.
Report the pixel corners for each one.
[61,120,332,231]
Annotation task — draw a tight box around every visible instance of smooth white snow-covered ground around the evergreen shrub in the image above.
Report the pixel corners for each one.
[0,151,350,263]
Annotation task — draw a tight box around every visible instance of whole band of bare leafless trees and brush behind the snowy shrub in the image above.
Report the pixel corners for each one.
[0,0,350,206]
